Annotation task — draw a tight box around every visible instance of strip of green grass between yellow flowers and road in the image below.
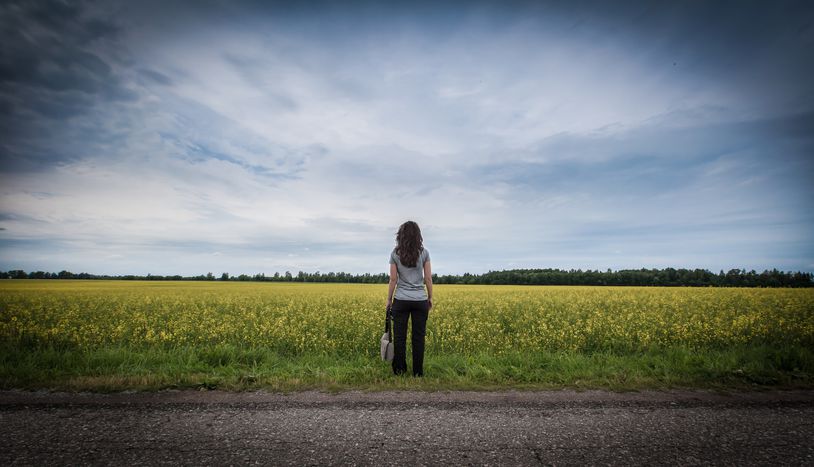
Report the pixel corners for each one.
[0,345,814,392]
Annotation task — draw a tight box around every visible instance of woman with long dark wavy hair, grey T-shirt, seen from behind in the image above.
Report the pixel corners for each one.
[387,221,432,376]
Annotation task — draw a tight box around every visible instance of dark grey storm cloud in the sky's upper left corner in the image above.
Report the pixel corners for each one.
[0,0,132,171]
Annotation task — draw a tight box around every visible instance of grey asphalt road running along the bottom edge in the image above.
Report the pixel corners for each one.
[0,391,814,465]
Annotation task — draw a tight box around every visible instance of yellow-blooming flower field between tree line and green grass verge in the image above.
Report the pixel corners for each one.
[0,280,814,392]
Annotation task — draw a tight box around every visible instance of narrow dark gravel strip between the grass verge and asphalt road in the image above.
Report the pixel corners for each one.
[6,389,814,408]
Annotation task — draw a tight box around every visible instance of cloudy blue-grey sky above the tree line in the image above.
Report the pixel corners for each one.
[0,1,814,275]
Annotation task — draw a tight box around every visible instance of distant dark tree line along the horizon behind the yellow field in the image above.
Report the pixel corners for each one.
[0,268,814,287]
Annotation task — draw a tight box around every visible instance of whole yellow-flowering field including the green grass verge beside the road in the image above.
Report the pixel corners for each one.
[0,280,814,391]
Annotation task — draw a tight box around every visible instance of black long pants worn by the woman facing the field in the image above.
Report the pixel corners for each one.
[392,299,430,376]
